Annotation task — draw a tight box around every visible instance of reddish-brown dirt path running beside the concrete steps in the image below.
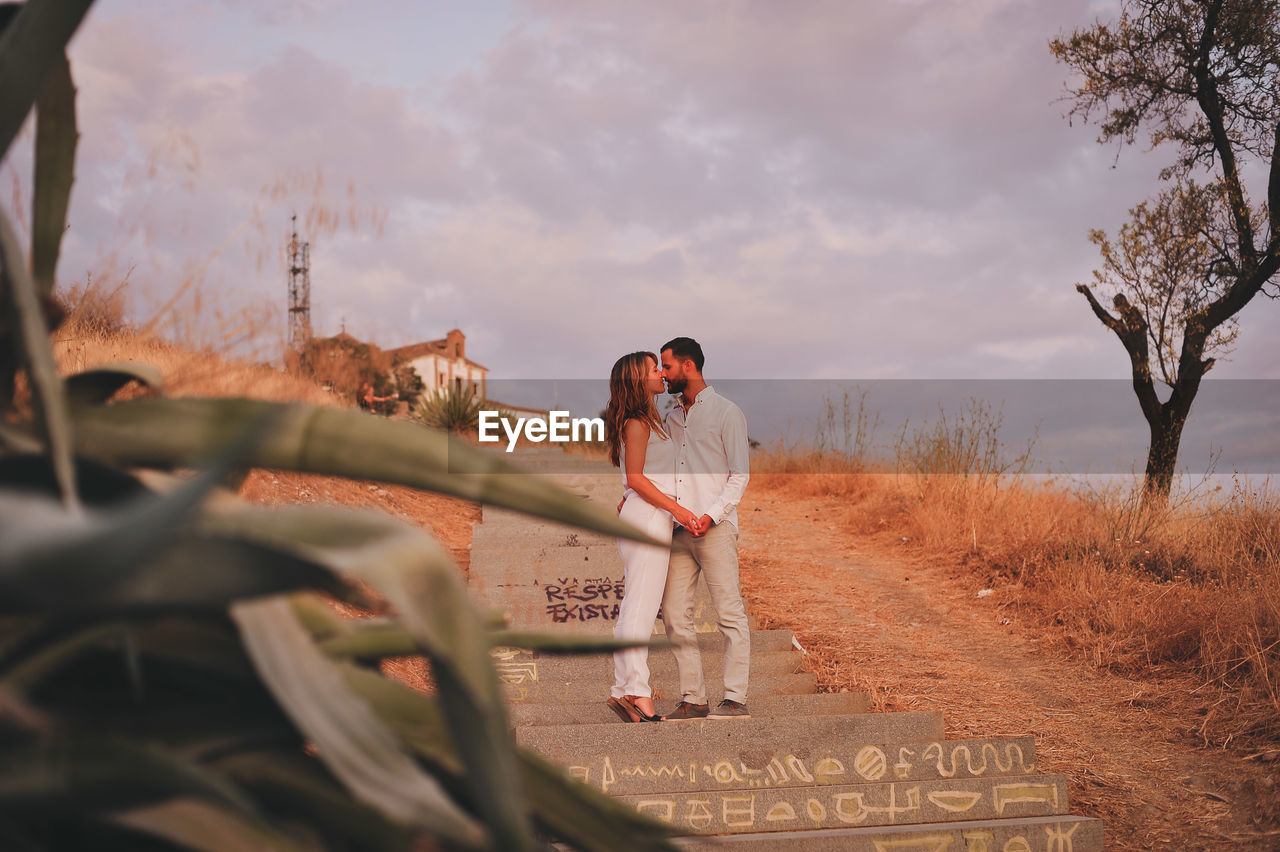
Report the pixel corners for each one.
[739,489,1280,849]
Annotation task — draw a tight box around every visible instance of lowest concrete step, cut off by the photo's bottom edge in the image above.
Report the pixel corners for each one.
[675,815,1103,852]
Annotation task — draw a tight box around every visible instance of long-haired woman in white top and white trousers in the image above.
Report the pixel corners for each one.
[604,352,698,722]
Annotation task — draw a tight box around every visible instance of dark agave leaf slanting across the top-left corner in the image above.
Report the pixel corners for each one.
[0,0,92,159]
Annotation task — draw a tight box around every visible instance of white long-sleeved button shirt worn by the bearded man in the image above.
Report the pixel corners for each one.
[664,385,750,528]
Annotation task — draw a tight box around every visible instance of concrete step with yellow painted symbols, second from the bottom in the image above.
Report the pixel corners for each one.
[618,775,1066,834]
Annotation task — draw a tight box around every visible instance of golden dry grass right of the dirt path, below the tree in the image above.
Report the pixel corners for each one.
[751,453,1280,750]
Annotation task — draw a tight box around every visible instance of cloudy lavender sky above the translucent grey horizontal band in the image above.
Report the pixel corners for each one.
[5,0,1280,380]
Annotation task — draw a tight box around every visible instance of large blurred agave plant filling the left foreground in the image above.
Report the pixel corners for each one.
[0,0,669,851]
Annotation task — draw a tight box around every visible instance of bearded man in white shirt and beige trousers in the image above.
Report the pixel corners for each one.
[662,338,751,720]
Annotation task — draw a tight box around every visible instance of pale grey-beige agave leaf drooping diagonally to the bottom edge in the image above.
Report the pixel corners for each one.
[232,599,485,847]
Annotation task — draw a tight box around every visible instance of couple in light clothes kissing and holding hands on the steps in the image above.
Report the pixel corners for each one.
[604,338,751,722]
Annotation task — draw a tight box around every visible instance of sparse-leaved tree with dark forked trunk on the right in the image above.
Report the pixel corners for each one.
[1051,0,1280,500]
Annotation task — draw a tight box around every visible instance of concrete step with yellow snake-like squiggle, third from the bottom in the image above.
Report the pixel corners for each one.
[560,731,1037,796]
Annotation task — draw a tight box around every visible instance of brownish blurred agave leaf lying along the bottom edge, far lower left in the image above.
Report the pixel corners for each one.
[109,798,312,852]
